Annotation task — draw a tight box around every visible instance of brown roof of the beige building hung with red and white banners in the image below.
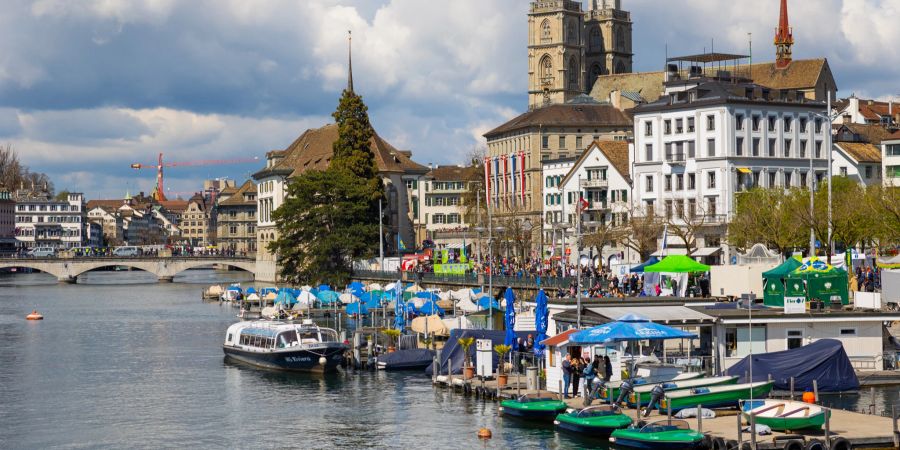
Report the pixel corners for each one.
[484,103,632,137]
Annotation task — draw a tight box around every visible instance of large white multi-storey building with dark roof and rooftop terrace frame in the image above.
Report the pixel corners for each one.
[632,54,830,262]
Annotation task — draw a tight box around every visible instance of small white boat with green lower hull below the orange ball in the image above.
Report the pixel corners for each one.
[741,400,831,431]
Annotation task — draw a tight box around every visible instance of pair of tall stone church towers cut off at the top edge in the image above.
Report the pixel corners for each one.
[528,0,632,109]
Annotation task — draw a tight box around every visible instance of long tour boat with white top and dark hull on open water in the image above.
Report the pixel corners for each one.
[222,320,349,372]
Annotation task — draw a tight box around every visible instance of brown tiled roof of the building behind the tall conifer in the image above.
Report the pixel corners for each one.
[264,124,428,177]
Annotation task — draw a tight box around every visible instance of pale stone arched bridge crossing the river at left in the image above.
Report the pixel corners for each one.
[0,256,256,283]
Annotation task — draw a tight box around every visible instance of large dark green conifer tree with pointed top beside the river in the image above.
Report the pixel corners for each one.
[269,89,383,285]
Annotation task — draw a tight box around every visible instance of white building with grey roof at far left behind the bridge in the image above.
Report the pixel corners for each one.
[15,190,86,248]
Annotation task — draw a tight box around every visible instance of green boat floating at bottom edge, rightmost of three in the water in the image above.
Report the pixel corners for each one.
[609,419,706,450]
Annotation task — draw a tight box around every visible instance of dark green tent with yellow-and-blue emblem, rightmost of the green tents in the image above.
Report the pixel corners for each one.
[785,258,850,305]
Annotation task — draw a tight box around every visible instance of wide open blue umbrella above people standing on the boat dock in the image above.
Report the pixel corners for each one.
[569,314,697,345]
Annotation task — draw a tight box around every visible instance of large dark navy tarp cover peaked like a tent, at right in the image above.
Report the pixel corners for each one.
[726,339,859,392]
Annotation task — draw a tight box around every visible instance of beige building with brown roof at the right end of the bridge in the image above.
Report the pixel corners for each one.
[217,180,256,255]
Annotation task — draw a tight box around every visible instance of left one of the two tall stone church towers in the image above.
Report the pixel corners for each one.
[528,0,588,109]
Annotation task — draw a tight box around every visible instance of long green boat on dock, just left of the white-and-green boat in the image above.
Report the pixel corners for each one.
[659,381,774,413]
